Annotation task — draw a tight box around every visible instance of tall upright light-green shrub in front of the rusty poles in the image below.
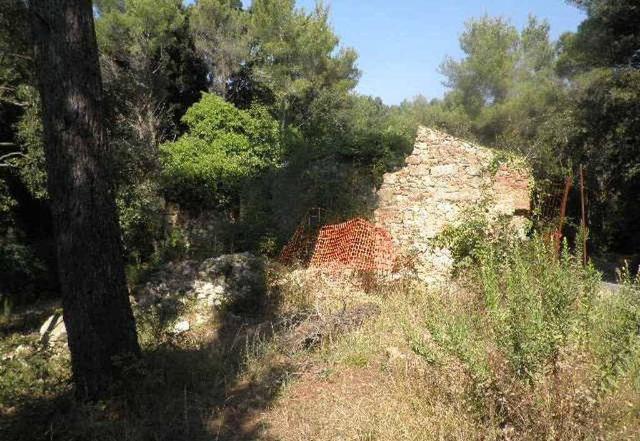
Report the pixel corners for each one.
[476,237,600,379]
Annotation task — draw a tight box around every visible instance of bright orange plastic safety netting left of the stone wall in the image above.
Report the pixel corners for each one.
[310,218,394,272]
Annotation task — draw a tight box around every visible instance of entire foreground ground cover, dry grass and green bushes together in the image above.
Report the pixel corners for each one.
[0,231,640,440]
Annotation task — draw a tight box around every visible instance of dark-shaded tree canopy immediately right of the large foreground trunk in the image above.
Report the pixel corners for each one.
[96,0,207,138]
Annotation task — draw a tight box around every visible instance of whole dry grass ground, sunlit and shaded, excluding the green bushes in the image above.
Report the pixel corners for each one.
[0,262,640,441]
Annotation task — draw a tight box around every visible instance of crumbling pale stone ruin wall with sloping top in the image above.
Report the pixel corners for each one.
[374,127,531,282]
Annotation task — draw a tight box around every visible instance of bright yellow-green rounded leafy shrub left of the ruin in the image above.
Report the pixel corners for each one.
[160,93,282,208]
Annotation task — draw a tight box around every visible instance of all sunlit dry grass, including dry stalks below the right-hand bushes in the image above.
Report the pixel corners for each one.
[262,264,640,441]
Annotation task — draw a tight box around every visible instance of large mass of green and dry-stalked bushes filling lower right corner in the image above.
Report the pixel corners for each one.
[405,222,640,439]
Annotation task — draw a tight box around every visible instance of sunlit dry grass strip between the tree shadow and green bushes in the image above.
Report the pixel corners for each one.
[263,278,483,440]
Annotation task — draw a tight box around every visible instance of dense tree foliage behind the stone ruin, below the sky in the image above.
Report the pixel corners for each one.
[0,0,640,306]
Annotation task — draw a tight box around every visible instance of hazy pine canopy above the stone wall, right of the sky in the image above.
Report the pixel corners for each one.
[438,16,563,159]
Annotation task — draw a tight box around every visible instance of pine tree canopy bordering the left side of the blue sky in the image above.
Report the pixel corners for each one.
[249,0,359,128]
